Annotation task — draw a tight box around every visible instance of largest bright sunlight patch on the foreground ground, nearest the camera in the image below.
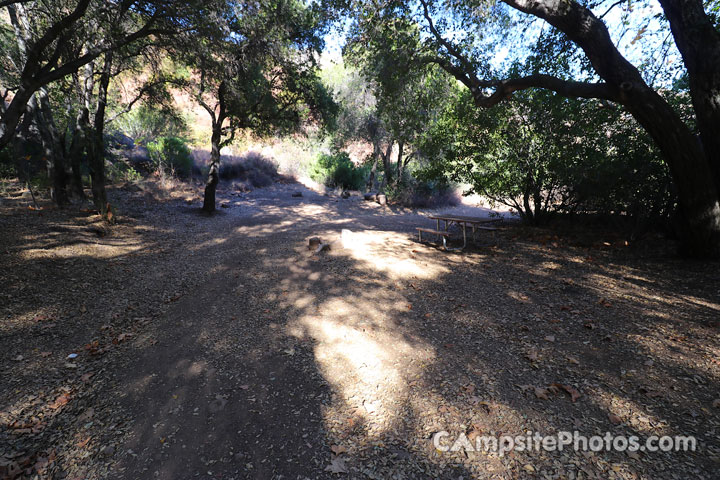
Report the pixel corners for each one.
[288,298,435,435]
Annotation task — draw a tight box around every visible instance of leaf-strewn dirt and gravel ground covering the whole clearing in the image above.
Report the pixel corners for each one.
[0,178,720,479]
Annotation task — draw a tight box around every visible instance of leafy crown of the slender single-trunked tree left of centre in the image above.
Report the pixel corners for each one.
[178,0,336,147]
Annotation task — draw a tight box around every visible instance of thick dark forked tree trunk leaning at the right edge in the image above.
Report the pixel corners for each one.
[496,0,720,257]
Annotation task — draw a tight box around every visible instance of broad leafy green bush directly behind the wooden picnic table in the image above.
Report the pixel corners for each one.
[419,84,675,223]
